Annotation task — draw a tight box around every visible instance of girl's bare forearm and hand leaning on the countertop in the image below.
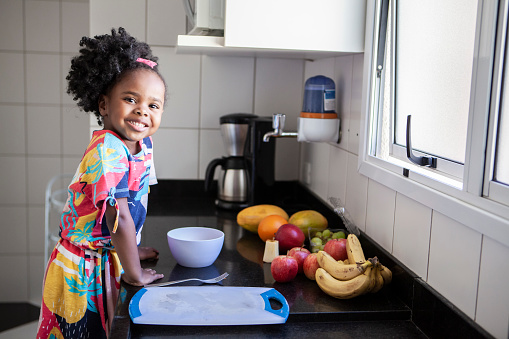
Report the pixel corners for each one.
[106,198,163,286]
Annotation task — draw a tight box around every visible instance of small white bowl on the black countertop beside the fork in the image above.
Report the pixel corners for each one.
[166,227,224,268]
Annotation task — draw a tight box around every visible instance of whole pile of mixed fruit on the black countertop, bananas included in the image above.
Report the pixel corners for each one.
[237,205,392,299]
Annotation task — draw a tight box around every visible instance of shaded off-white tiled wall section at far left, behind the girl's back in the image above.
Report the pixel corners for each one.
[0,0,89,302]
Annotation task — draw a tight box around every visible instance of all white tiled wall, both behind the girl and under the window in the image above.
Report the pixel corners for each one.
[0,0,509,338]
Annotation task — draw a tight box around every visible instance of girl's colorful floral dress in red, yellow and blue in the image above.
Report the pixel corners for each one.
[37,130,157,339]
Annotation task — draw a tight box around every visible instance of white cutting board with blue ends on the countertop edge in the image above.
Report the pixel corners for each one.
[129,286,290,325]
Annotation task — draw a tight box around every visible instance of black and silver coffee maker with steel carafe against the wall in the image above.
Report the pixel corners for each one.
[205,113,275,210]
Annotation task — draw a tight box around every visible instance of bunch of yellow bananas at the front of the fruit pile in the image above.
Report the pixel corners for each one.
[315,234,392,299]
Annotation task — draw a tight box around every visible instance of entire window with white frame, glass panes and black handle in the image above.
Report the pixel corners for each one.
[359,0,509,238]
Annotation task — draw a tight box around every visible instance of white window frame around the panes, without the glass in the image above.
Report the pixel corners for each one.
[358,0,509,246]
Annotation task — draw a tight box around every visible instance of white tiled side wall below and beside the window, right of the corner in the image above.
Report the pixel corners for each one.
[300,55,509,338]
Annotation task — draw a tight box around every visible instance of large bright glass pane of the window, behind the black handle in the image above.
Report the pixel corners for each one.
[395,0,477,163]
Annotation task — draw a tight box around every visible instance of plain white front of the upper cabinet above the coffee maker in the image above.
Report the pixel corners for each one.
[225,0,366,53]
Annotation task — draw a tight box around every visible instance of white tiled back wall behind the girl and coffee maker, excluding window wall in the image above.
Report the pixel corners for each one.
[0,0,304,304]
